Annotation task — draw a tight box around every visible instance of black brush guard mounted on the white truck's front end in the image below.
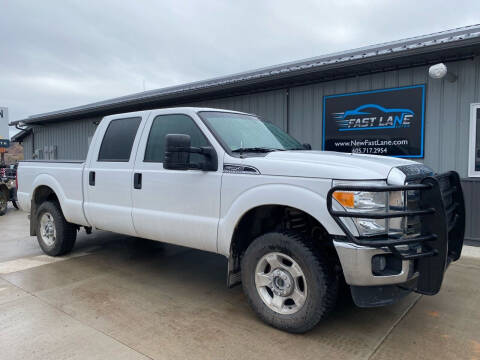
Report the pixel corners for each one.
[327,171,465,295]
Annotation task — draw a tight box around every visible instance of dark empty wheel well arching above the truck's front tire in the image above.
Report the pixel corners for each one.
[229,205,339,273]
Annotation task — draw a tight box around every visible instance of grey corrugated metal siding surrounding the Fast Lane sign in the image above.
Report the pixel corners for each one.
[288,59,480,177]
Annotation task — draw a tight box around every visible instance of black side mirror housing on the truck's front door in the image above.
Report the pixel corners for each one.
[163,134,190,170]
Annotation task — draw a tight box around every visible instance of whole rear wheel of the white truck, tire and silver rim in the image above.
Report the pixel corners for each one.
[37,201,77,256]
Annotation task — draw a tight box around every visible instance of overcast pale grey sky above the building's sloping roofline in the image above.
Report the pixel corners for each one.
[0,0,480,136]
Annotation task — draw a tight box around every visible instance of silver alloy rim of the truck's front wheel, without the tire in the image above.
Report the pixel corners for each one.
[255,252,307,315]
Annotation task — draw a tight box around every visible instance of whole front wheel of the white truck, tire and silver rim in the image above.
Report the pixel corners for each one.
[242,233,338,333]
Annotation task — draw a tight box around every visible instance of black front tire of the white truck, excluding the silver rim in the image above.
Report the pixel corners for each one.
[241,232,339,333]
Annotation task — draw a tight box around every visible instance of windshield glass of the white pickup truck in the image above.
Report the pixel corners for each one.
[200,111,305,152]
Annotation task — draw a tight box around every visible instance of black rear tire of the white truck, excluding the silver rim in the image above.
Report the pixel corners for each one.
[37,201,77,256]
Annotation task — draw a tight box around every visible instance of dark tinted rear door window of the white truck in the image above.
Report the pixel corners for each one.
[98,117,142,162]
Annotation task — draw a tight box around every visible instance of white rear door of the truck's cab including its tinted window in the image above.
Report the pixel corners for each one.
[84,112,148,236]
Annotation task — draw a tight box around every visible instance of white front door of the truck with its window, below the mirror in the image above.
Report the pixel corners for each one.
[133,114,222,252]
